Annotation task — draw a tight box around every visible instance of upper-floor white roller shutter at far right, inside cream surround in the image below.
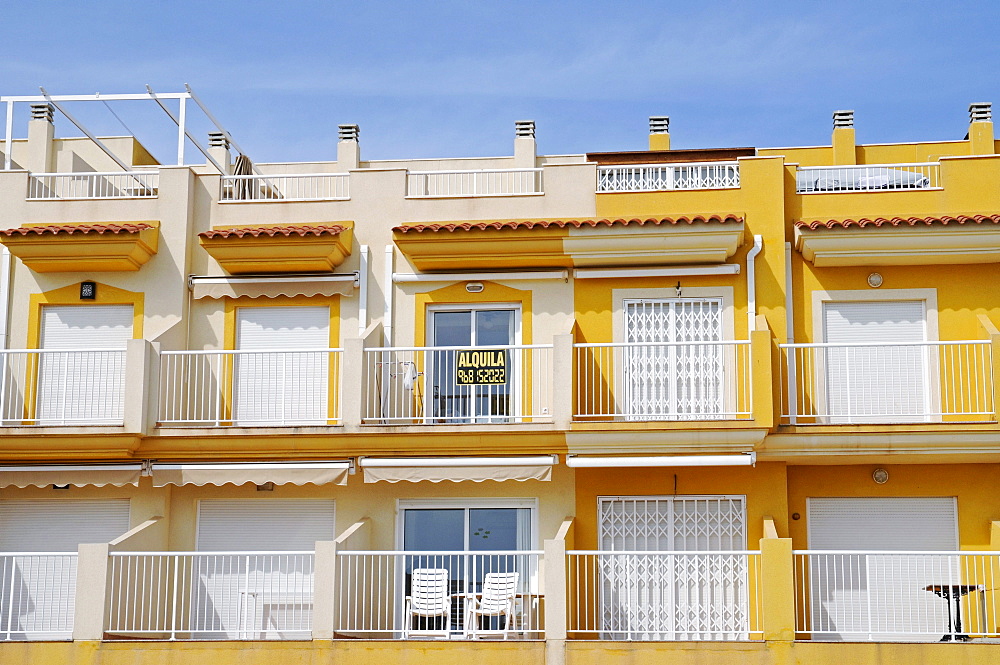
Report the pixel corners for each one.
[820,300,936,422]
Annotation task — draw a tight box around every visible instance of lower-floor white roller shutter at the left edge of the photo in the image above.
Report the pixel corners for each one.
[0,499,129,640]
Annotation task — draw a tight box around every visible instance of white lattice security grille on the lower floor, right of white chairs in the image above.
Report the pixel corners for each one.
[598,496,750,640]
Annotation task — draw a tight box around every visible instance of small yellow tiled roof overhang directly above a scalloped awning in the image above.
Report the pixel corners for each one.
[198,222,354,275]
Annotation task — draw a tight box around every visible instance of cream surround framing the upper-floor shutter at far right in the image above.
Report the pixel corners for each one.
[812,288,942,424]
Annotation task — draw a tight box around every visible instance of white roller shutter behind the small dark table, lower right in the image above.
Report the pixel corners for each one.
[808,497,961,640]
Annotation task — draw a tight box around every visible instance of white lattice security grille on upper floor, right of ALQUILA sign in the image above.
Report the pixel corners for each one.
[623,299,725,420]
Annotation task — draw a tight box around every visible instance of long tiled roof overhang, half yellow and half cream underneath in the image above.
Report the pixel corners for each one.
[393,213,744,271]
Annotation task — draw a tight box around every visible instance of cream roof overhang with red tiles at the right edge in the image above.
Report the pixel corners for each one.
[794,213,1000,267]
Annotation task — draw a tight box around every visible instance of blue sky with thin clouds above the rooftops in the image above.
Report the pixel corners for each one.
[0,0,1000,161]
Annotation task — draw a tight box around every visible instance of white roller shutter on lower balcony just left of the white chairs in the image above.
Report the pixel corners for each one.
[191,499,335,639]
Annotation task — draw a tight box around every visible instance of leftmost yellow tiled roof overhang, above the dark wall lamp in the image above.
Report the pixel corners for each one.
[0,221,159,272]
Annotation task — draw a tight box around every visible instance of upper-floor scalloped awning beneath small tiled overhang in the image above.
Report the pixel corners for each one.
[188,273,358,300]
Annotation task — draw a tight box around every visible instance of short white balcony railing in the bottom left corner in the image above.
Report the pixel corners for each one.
[0,552,77,641]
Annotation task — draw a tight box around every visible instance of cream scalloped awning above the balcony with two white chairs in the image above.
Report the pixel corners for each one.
[359,455,559,483]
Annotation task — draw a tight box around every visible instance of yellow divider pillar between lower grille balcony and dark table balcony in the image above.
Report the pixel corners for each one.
[760,517,795,642]
